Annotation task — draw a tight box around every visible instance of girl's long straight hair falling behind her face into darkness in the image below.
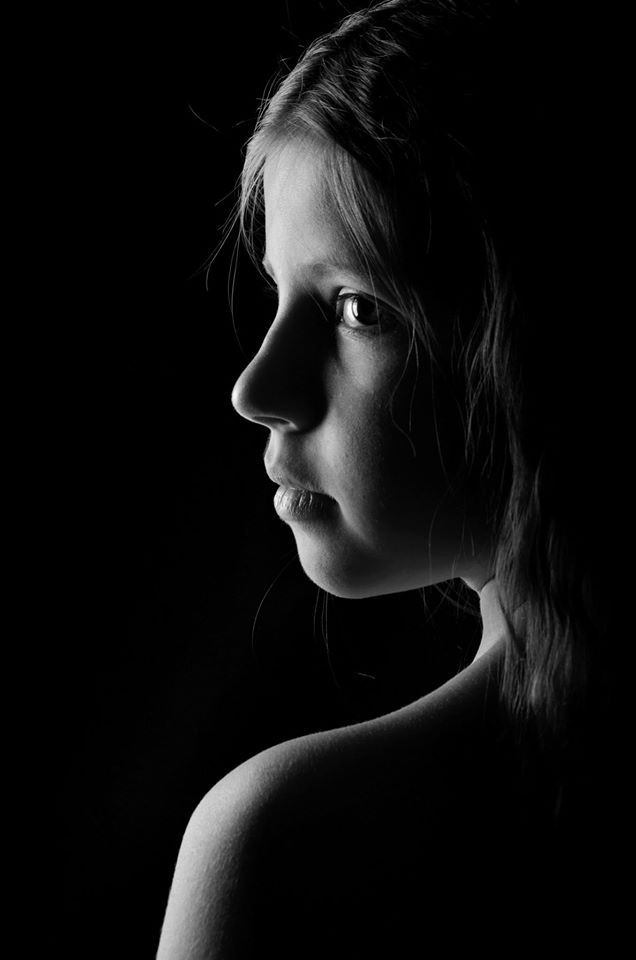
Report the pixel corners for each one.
[231,0,611,764]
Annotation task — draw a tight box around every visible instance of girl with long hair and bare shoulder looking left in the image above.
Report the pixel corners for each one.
[158,0,620,960]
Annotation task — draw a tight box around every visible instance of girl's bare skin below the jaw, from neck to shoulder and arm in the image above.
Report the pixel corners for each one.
[157,579,516,960]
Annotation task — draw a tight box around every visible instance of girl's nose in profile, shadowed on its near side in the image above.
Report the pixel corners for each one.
[232,311,324,432]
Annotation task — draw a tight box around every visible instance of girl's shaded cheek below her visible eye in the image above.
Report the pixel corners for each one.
[330,344,465,524]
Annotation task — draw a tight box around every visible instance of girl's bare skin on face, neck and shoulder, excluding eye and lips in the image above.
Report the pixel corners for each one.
[157,144,507,960]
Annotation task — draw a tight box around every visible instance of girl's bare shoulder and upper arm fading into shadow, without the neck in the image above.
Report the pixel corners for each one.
[158,644,504,960]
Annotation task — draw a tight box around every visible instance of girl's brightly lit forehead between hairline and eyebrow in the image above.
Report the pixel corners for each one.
[263,139,355,264]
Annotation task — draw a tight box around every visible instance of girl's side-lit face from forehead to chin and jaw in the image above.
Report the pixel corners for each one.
[232,141,490,597]
